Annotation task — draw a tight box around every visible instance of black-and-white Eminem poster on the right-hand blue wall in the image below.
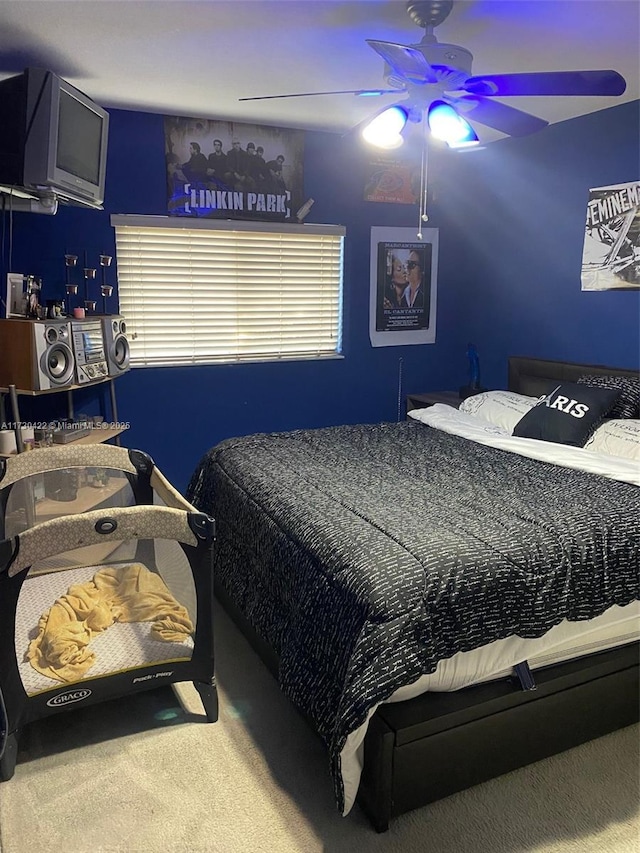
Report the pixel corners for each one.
[582,181,640,290]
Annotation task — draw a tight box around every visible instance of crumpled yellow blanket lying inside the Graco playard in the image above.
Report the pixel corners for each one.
[26,563,193,682]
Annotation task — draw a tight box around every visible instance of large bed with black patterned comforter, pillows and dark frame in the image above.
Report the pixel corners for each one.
[188,357,640,831]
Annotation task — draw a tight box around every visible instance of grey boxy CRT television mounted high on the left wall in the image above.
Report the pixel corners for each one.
[0,68,109,208]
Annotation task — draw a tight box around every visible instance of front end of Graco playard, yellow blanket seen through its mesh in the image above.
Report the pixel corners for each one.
[0,502,218,781]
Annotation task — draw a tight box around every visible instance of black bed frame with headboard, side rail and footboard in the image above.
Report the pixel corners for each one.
[217,357,640,832]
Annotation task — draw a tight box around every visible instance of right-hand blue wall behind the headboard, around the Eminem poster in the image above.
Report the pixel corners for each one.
[432,101,640,387]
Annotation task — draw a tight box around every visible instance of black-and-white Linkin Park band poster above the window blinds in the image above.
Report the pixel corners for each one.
[164,116,304,221]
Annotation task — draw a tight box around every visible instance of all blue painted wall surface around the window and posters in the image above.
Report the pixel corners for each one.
[4,102,640,489]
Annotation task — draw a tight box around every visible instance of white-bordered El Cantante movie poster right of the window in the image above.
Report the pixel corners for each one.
[369,228,438,347]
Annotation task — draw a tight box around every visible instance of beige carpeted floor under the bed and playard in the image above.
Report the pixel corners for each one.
[0,608,640,853]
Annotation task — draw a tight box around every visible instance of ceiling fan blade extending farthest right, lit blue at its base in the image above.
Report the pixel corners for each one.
[462,71,627,96]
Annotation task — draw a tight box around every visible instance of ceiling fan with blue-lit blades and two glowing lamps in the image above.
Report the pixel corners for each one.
[240,0,626,148]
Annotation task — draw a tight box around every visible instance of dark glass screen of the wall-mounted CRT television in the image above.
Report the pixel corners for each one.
[56,89,102,184]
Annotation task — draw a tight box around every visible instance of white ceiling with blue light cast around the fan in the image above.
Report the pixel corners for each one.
[0,0,640,142]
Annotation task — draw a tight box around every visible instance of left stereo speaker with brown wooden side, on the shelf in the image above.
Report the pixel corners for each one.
[0,319,75,391]
